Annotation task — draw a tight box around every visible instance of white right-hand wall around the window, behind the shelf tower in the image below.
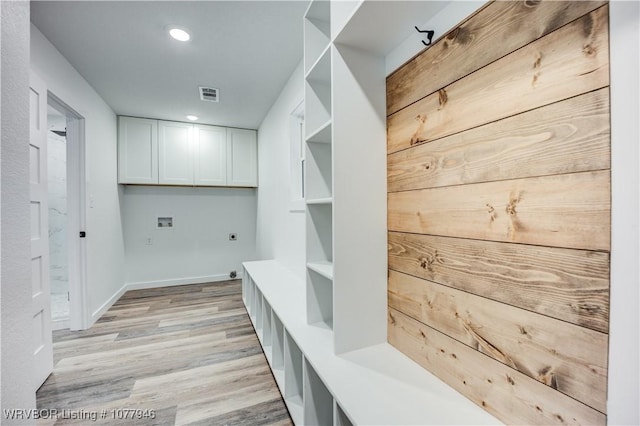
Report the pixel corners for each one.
[256,62,305,279]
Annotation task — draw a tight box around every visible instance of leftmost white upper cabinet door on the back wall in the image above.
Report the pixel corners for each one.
[118,117,158,184]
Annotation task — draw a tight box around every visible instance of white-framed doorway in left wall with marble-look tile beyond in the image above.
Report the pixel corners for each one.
[47,92,90,330]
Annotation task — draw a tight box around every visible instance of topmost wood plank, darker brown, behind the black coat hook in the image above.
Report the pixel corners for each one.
[387,1,605,115]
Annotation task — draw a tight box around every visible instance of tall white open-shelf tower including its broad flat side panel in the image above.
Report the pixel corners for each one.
[304,1,387,354]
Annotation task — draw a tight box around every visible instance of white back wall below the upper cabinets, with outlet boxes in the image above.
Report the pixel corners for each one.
[122,185,256,288]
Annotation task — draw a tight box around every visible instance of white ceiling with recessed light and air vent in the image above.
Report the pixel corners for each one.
[31,0,308,129]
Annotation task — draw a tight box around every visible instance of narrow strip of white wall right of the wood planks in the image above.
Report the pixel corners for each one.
[607,1,640,425]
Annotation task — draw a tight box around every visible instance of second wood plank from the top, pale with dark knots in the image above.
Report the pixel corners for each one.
[387,6,609,153]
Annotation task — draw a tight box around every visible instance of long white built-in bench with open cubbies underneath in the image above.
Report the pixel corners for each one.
[242,260,501,425]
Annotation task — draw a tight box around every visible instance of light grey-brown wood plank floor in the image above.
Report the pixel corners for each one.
[37,281,292,425]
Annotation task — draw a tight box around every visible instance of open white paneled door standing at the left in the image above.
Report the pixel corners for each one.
[29,73,53,390]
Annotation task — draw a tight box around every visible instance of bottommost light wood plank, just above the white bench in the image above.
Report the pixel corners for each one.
[388,309,606,425]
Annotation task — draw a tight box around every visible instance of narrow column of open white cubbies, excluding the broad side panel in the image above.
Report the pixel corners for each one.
[304,1,334,340]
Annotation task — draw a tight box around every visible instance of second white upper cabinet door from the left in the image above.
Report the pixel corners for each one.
[158,121,193,185]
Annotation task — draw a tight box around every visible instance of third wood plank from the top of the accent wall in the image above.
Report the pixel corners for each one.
[387,88,611,192]
